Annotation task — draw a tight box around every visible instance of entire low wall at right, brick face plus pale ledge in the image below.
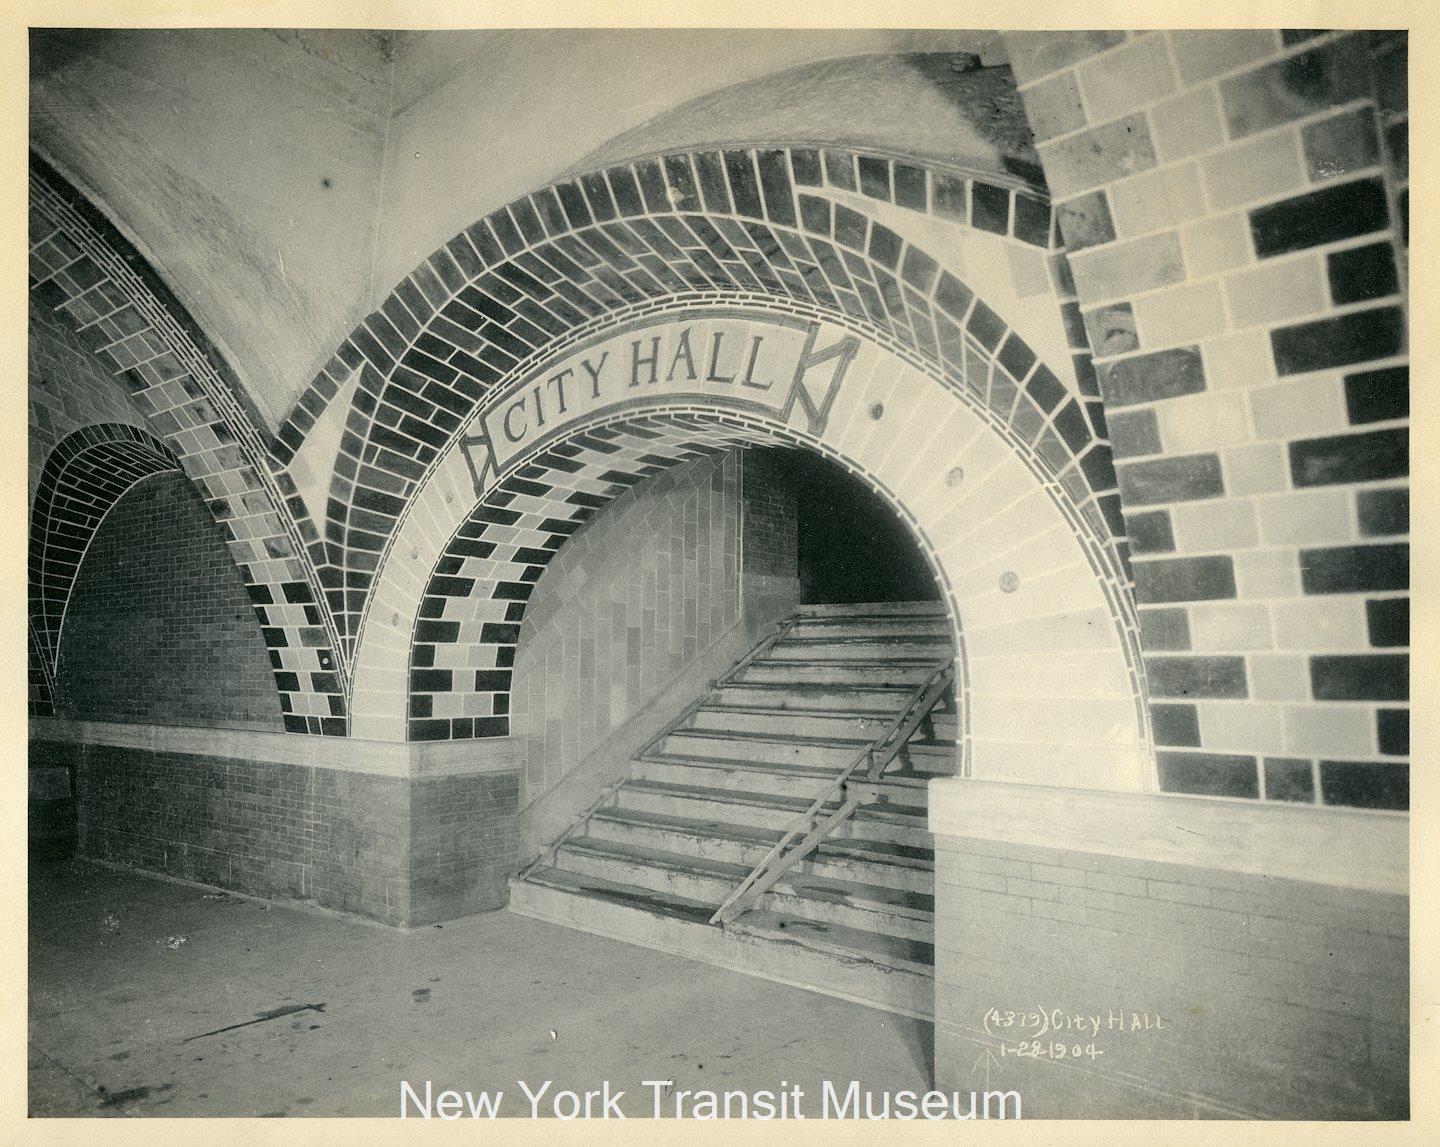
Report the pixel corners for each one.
[930,780,1408,1120]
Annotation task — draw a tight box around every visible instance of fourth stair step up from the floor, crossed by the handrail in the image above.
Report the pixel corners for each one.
[612,780,930,849]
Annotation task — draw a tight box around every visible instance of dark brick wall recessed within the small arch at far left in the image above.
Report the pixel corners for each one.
[58,472,281,730]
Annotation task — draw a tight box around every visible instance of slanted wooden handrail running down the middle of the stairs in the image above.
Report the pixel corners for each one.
[710,662,955,925]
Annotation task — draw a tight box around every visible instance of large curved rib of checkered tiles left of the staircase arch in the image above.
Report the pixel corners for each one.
[30,155,347,735]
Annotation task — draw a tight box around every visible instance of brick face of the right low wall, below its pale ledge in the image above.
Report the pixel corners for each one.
[936,836,1408,1120]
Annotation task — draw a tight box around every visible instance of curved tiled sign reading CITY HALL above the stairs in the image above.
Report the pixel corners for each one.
[461,308,860,489]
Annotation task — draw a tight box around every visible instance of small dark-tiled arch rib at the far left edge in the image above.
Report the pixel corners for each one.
[29,423,179,717]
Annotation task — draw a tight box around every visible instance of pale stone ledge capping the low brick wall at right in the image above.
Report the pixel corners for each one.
[929,777,1410,895]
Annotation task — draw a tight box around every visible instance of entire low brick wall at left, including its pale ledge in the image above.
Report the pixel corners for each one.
[30,721,520,927]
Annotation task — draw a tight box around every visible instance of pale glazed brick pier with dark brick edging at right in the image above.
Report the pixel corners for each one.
[1007,29,1410,809]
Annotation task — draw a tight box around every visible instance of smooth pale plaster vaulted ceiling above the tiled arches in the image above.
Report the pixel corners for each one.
[30,30,1019,429]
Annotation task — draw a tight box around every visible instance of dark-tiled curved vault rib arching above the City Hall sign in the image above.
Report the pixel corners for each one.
[275,147,1129,667]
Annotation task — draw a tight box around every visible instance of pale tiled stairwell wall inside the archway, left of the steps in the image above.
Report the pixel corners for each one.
[511,452,740,803]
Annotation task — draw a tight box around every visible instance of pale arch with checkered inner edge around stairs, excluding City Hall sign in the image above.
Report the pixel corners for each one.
[353,299,1149,787]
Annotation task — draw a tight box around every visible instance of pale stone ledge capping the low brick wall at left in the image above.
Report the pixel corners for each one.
[30,717,520,779]
